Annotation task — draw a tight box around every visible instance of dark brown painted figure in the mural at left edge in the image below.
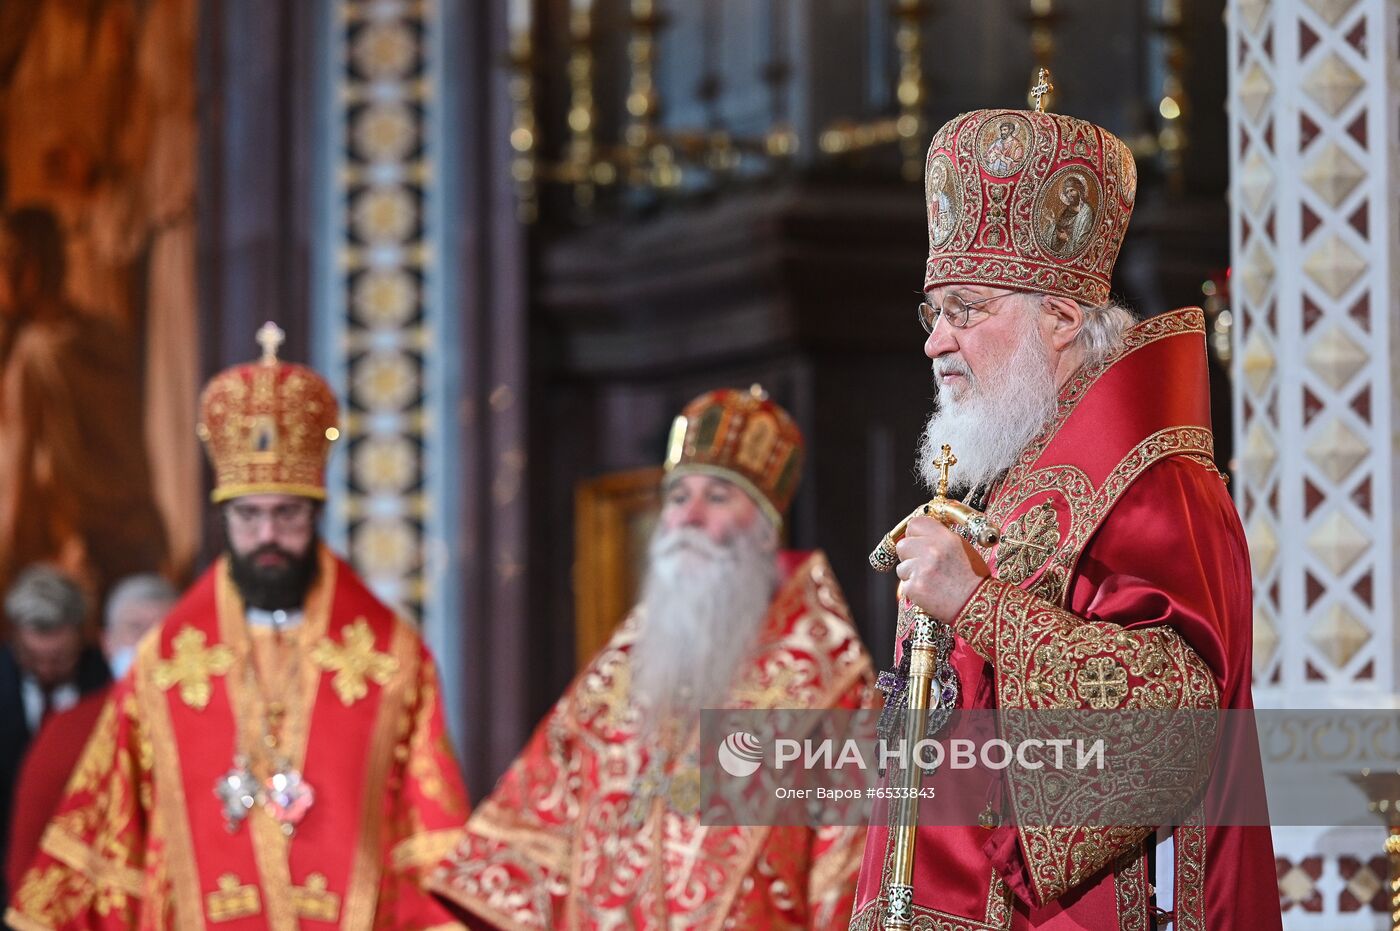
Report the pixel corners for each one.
[0,207,167,613]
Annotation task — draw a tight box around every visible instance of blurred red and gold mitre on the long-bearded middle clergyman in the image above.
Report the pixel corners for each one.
[666,385,802,526]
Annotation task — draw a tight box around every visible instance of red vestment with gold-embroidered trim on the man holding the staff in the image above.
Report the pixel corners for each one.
[851,308,1281,931]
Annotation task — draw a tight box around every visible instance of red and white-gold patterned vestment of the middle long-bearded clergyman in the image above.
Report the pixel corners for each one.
[431,553,872,931]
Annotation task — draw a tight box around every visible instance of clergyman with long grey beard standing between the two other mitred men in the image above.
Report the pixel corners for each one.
[433,388,872,931]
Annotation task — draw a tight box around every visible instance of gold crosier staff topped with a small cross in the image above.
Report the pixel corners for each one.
[869,444,1001,931]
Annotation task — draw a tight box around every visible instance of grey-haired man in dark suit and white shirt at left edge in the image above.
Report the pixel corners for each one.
[0,566,112,899]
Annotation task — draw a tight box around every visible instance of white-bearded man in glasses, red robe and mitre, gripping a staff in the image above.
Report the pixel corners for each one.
[851,95,1281,931]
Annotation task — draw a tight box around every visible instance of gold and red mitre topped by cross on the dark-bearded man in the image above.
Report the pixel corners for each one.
[196,322,340,503]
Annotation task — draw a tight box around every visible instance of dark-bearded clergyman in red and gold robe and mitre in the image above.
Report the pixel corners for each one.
[6,323,468,931]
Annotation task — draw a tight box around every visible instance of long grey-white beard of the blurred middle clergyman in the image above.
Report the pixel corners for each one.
[631,522,777,724]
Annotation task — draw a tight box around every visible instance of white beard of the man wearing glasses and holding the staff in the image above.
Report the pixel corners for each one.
[918,314,1057,494]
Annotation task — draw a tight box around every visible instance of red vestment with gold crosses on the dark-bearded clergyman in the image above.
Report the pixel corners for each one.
[6,547,468,931]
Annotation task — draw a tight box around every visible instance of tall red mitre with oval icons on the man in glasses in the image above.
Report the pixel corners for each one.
[924,74,1137,307]
